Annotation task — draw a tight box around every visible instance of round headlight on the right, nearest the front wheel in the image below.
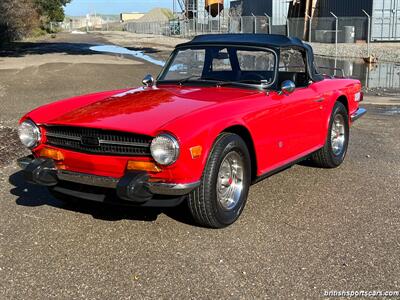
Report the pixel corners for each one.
[150,134,179,165]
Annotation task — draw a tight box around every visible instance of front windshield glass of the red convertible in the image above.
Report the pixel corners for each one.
[158,46,277,87]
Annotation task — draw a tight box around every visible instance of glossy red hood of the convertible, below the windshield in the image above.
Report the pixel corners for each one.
[28,86,257,135]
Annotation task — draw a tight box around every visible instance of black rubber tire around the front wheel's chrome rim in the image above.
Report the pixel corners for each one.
[188,133,251,228]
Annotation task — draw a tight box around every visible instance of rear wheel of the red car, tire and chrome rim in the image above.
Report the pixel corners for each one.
[312,102,349,168]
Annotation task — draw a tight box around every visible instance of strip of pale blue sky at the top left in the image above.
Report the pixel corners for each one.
[65,0,172,16]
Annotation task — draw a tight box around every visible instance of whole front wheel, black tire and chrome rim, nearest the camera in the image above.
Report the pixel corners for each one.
[188,133,251,228]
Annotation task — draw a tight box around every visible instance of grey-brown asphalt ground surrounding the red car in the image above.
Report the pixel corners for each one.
[0,33,400,299]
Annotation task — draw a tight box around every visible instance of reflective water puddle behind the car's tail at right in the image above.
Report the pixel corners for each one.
[315,57,400,91]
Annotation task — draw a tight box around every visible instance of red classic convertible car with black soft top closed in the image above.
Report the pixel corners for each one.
[18,34,366,228]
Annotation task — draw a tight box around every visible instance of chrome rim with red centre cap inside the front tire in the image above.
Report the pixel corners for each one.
[217,152,244,210]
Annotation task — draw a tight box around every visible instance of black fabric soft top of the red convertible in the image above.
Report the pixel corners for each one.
[177,33,323,81]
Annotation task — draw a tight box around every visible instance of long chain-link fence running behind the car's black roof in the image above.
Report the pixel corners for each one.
[123,15,374,43]
